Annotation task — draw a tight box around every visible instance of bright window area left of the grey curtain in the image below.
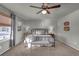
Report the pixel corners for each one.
[0,14,12,54]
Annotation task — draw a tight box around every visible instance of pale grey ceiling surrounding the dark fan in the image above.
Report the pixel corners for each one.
[2,3,79,20]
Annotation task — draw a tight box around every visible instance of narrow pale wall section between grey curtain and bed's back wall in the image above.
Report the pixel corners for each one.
[15,17,24,45]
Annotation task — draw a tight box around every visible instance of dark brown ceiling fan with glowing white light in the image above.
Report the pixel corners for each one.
[30,3,61,14]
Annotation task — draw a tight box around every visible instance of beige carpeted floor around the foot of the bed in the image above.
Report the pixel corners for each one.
[2,41,79,56]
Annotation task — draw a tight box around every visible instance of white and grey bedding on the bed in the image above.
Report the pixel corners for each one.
[24,35,54,48]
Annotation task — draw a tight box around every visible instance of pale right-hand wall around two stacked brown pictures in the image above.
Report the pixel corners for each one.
[57,10,79,50]
